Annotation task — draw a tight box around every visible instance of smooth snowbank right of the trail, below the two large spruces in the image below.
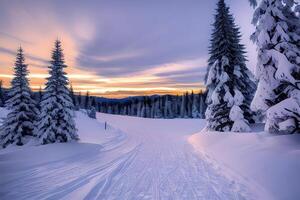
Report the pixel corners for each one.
[189,131,300,199]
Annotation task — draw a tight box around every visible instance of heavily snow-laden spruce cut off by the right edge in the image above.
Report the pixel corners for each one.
[251,0,300,133]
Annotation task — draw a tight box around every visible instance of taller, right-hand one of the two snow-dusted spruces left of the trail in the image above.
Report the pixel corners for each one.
[38,40,78,144]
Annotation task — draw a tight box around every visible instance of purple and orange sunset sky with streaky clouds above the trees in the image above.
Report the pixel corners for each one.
[0,0,256,98]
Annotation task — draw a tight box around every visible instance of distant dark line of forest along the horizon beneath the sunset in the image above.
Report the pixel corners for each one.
[0,85,207,119]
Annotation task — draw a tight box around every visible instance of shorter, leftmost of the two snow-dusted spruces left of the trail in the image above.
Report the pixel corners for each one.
[0,47,39,148]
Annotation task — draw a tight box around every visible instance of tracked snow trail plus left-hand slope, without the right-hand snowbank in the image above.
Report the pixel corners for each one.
[0,113,256,200]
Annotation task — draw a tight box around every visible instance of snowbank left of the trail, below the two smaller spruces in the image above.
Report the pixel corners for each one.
[0,108,124,165]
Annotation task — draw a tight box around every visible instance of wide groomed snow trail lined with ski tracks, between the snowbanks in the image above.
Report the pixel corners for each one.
[0,114,255,200]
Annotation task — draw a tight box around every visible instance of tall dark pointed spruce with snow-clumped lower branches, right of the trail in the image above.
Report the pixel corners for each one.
[205,0,256,132]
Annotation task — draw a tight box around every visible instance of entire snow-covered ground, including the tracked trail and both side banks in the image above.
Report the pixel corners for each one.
[0,110,300,200]
